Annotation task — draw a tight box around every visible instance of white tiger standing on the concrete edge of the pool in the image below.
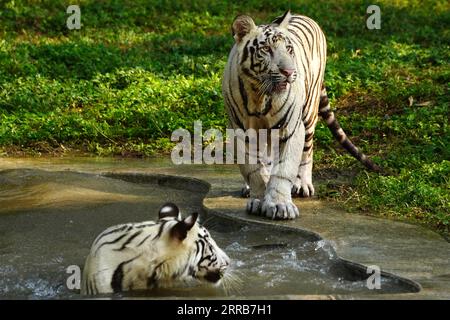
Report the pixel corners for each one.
[222,11,378,219]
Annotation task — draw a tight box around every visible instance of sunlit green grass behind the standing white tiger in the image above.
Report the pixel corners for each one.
[0,0,450,234]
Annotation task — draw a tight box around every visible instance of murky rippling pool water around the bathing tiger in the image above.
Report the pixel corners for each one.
[0,169,411,299]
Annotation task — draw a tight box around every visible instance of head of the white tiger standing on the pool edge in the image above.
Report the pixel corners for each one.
[232,11,297,94]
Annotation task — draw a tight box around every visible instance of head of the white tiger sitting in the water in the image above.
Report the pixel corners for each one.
[159,203,230,285]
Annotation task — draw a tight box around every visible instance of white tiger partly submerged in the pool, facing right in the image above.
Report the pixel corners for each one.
[81,203,230,295]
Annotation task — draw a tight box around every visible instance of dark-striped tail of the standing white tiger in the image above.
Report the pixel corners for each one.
[319,87,382,172]
